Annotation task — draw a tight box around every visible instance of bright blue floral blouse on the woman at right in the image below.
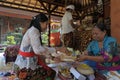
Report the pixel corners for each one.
[87,36,120,70]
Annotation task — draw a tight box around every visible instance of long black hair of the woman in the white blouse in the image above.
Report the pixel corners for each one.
[28,13,48,32]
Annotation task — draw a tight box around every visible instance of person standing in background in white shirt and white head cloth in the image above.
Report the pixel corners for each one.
[61,5,75,47]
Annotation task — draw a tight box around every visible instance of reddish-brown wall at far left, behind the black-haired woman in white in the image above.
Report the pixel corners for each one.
[0,15,30,43]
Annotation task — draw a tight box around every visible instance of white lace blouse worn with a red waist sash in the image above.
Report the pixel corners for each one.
[15,26,55,70]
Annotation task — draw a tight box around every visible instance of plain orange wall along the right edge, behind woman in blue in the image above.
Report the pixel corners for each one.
[111,0,120,44]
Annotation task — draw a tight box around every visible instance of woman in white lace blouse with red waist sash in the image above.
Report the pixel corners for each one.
[14,13,67,80]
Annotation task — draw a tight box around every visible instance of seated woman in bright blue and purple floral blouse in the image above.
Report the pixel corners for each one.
[77,23,120,77]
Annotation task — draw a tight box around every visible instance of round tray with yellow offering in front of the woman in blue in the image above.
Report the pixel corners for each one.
[76,63,94,75]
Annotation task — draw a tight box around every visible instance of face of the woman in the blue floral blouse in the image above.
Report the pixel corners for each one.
[92,27,106,41]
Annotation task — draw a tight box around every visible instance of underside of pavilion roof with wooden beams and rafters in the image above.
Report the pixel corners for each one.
[0,0,97,17]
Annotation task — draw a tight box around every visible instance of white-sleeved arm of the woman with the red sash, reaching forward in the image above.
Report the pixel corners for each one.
[29,29,67,55]
